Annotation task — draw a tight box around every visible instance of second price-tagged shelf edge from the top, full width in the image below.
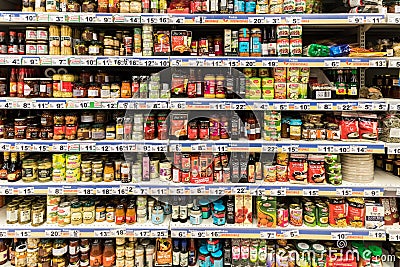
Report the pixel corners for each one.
[0,54,387,68]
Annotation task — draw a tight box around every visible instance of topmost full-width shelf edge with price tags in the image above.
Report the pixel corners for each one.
[0,11,388,25]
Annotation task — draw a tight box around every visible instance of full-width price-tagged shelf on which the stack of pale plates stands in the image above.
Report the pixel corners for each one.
[0,170,400,197]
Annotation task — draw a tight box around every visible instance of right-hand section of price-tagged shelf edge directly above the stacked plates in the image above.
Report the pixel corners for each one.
[170,139,385,154]
